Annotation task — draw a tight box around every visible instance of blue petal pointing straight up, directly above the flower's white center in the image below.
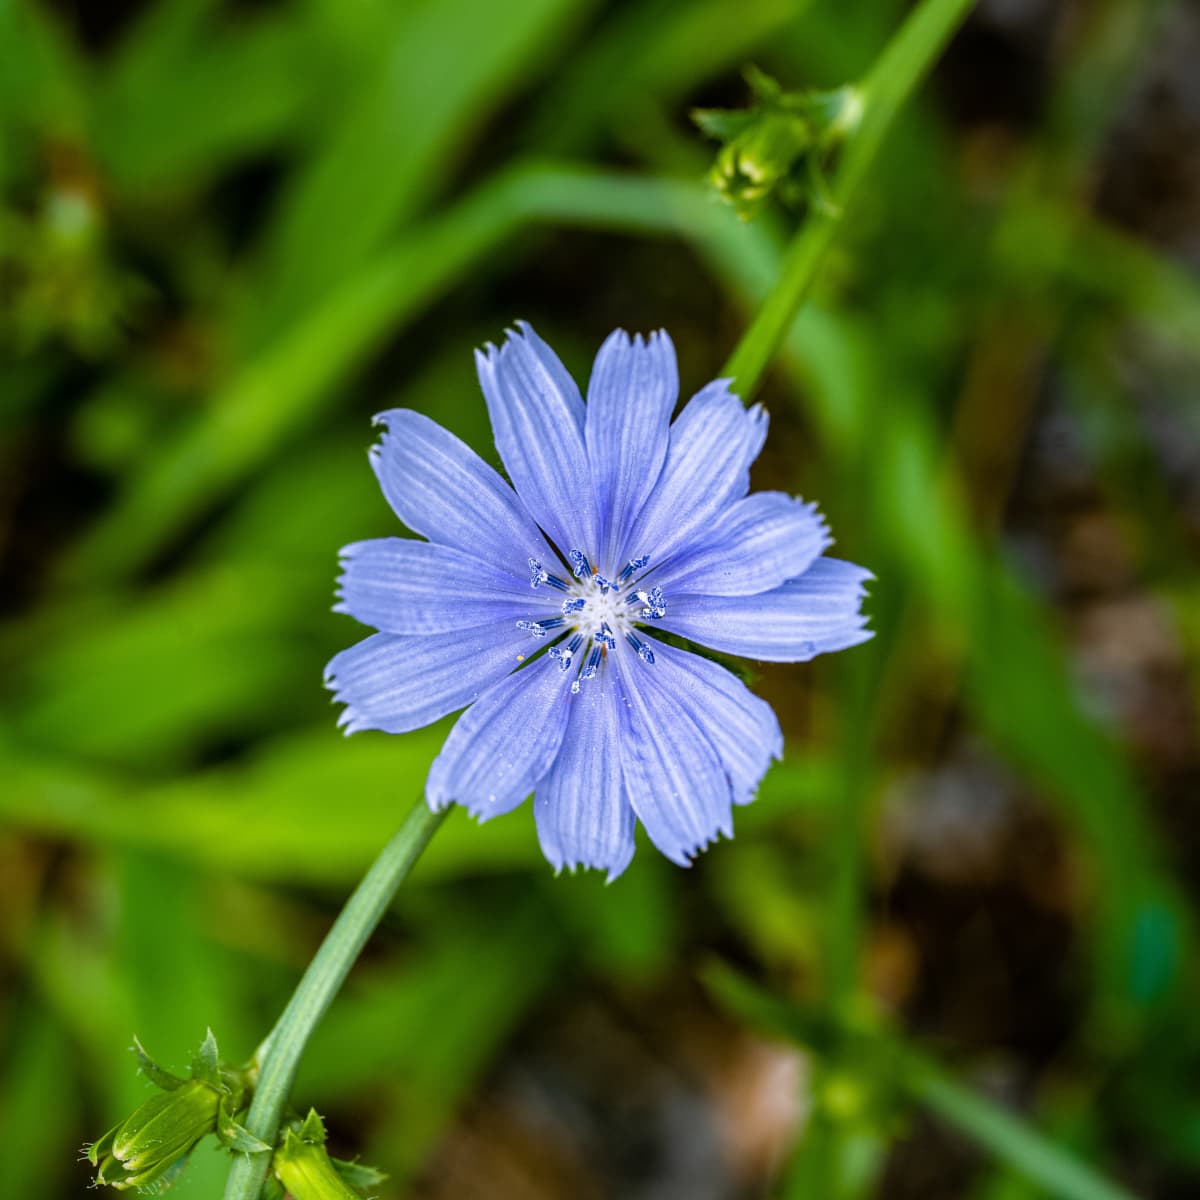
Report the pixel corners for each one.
[586,329,679,571]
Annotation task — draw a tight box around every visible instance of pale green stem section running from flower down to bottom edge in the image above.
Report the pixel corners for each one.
[224,799,449,1200]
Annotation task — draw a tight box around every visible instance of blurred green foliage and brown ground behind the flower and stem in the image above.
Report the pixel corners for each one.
[0,0,1200,1200]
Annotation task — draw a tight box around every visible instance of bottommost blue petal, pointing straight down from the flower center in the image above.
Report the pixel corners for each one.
[533,679,634,882]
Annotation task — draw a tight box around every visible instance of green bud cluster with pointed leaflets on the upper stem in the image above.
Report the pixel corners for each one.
[692,67,862,220]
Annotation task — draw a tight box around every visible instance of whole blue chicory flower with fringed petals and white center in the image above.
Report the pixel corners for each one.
[326,323,871,878]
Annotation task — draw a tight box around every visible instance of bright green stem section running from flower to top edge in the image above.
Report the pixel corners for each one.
[721,0,974,401]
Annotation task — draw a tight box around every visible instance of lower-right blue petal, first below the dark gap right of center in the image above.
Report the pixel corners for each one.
[649,638,784,804]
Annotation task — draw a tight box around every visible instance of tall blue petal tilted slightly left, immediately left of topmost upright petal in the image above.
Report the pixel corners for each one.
[475,322,596,553]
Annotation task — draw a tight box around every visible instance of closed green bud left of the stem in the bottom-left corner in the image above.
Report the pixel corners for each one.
[88,1080,221,1190]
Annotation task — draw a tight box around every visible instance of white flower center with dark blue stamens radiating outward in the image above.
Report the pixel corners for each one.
[517,550,667,692]
